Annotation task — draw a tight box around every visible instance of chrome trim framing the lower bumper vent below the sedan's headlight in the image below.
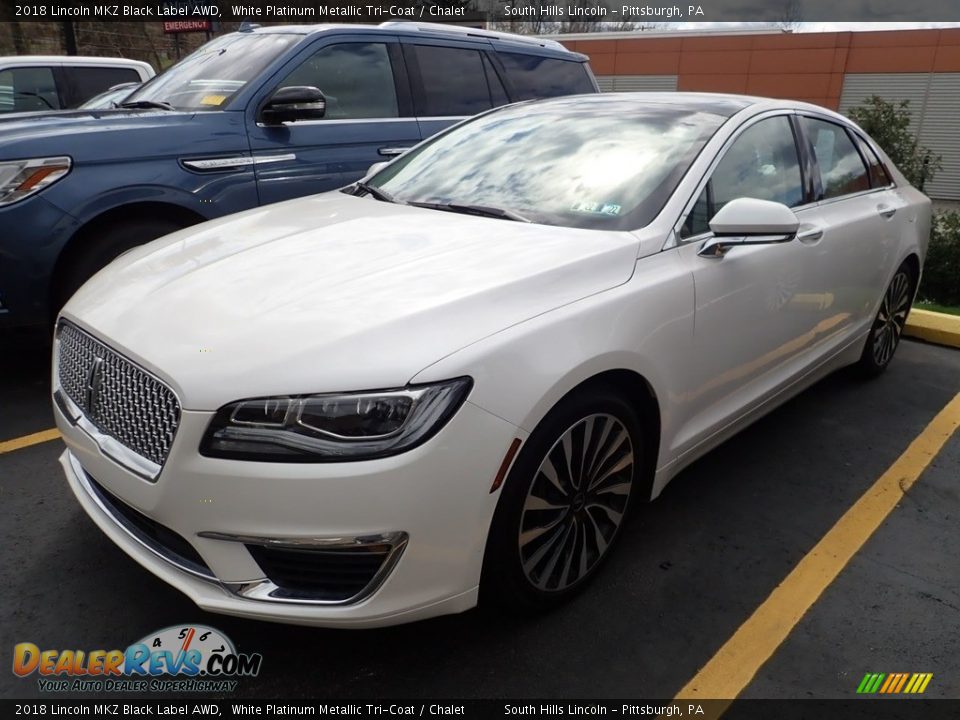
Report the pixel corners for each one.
[208,532,409,606]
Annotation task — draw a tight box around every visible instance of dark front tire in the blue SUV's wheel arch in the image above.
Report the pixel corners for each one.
[53,219,184,314]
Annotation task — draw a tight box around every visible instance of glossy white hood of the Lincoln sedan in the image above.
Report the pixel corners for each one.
[63,192,638,410]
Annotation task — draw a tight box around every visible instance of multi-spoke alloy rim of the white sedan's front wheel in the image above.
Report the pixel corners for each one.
[519,414,634,591]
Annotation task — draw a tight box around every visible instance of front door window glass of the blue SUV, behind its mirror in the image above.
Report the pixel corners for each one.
[277,43,399,120]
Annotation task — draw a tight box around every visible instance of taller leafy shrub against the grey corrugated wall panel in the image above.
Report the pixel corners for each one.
[849,95,943,190]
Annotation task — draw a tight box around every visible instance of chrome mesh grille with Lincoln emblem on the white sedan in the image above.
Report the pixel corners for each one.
[57,322,180,465]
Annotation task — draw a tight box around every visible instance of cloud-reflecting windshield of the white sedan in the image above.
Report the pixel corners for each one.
[368,96,726,230]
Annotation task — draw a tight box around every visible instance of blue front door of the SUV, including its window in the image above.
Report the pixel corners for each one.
[247,33,420,204]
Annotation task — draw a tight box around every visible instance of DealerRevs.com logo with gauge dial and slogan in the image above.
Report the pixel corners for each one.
[13,625,263,692]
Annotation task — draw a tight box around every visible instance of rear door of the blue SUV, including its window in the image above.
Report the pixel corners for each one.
[402,37,509,138]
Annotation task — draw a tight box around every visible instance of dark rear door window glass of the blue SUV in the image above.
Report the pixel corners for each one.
[413,45,493,117]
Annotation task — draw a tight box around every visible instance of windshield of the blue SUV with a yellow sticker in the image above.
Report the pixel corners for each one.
[124,33,302,110]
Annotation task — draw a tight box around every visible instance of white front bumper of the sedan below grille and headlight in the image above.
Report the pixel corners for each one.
[55,402,525,627]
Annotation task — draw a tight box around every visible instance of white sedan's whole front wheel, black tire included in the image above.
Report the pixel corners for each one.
[480,386,643,612]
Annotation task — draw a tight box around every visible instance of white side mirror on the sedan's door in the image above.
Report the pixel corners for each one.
[698,198,800,257]
